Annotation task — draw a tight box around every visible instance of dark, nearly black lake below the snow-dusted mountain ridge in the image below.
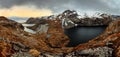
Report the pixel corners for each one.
[65,26,107,47]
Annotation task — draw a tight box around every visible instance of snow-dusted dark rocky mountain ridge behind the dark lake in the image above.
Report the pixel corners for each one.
[26,10,119,29]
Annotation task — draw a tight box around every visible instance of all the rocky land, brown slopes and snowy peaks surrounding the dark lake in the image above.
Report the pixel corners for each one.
[0,10,120,57]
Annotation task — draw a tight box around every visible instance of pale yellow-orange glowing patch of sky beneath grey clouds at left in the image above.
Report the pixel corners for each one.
[0,6,53,17]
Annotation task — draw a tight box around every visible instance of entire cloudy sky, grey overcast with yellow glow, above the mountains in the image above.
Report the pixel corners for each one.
[0,0,120,17]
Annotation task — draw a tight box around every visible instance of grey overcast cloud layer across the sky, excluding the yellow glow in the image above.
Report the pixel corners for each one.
[0,0,120,14]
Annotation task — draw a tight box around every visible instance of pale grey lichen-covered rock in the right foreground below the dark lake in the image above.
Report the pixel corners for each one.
[66,47,113,57]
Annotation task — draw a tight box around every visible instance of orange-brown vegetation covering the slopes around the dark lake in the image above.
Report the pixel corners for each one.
[0,17,120,57]
